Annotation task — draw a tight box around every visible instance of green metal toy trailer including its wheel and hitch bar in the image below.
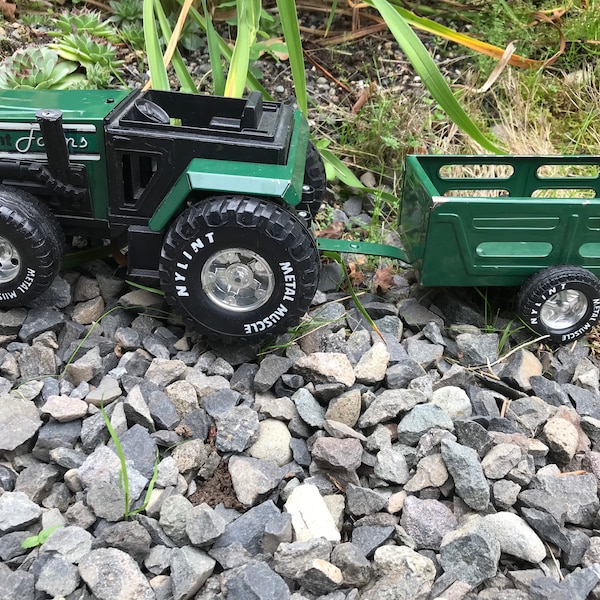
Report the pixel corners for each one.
[320,155,600,343]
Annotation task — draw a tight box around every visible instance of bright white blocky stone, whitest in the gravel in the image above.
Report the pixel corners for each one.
[284,483,341,542]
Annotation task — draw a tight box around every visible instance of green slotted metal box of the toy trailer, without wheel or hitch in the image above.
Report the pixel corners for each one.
[400,155,600,286]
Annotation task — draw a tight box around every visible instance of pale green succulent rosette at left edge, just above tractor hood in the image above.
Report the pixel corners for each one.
[0,47,85,90]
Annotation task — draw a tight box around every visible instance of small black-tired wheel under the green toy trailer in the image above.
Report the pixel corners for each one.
[518,265,600,343]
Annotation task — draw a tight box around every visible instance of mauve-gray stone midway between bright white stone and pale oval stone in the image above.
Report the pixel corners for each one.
[400,496,458,551]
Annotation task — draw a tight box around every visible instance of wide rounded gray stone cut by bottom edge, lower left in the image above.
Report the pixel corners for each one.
[79,548,155,600]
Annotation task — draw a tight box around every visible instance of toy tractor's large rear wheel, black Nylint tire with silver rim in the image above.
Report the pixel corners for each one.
[159,196,320,341]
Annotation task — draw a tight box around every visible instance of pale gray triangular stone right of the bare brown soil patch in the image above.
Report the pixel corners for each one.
[228,456,285,506]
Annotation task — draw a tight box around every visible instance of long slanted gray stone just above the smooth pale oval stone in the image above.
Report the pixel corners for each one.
[442,440,490,511]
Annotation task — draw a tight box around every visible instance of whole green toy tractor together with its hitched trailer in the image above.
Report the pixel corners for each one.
[0,90,600,343]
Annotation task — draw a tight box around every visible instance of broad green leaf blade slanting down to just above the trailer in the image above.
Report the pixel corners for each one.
[365,0,505,154]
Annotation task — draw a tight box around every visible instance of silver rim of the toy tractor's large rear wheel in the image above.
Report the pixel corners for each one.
[201,248,275,312]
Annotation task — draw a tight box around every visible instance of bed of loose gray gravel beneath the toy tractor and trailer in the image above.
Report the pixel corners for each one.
[0,192,600,600]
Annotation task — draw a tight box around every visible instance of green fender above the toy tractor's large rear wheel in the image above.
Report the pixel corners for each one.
[149,112,308,231]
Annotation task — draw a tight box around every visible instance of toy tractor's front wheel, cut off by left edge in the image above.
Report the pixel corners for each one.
[0,185,64,308]
